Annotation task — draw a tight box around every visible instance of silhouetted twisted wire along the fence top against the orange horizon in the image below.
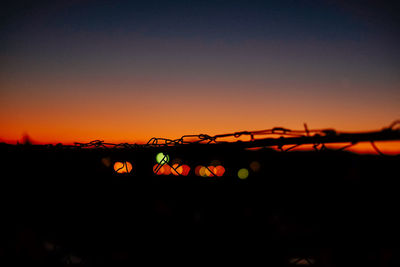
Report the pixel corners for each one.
[67,120,400,155]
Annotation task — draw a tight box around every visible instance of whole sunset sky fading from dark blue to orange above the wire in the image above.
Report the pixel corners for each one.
[0,0,400,151]
